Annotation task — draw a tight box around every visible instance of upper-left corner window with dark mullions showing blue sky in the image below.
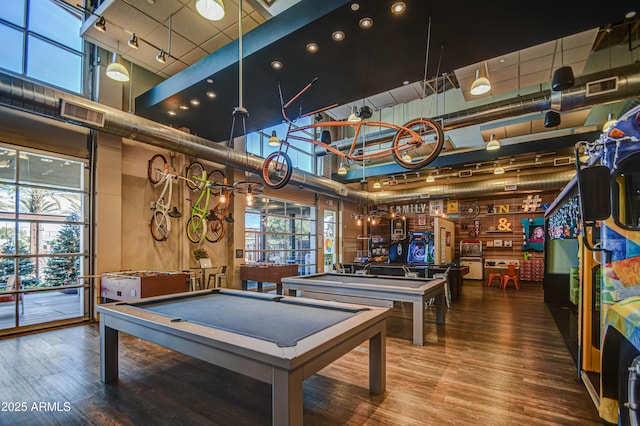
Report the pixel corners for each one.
[0,0,83,93]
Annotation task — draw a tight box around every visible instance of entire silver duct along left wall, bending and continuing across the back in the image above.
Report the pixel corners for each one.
[0,73,574,203]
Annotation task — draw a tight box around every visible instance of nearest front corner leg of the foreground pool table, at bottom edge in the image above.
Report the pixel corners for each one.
[271,367,304,425]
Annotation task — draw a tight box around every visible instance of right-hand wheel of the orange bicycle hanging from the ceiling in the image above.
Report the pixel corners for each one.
[392,118,444,170]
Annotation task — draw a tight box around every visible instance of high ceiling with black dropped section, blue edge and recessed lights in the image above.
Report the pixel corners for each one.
[77,0,640,180]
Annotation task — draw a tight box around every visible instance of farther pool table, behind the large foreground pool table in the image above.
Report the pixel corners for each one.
[282,273,445,346]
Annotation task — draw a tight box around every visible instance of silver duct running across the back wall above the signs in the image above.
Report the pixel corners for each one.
[370,169,576,203]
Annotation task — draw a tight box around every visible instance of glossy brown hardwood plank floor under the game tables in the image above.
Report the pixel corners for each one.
[0,281,601,425]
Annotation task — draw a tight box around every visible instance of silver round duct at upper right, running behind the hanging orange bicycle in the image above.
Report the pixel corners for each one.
[315,62,640,155]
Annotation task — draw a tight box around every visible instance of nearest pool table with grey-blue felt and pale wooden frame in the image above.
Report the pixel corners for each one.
[98,289,388,425]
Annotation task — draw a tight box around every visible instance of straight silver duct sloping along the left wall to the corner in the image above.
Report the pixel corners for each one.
[0,73,369,202]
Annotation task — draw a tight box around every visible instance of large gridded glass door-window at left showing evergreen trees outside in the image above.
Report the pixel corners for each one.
[0,146,89,333]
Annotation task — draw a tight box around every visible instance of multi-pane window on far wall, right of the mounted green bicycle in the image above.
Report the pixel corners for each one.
[245,197,317,275]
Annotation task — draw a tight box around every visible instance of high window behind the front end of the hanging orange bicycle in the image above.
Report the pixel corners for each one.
[247,117,316,173]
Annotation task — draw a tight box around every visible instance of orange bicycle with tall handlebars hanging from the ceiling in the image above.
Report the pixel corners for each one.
[262,78,444,189]
